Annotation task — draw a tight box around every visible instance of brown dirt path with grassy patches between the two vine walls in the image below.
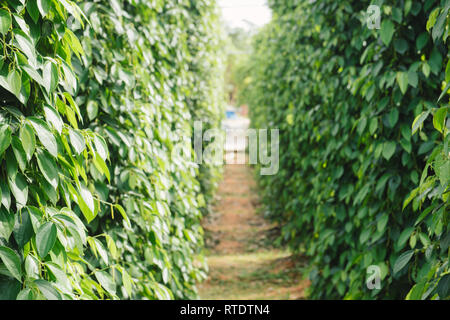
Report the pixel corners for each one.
[199,165,308,300]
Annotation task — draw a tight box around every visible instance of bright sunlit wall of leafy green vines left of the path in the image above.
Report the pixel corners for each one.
[0,0,221,299]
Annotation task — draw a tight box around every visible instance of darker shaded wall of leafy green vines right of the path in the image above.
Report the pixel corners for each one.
[243,0,450,299]
